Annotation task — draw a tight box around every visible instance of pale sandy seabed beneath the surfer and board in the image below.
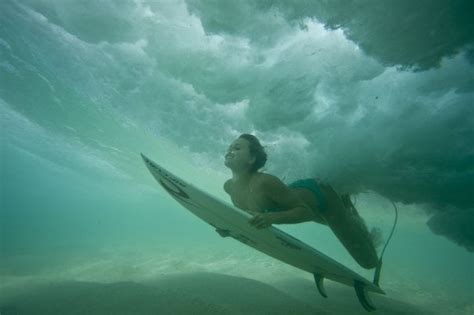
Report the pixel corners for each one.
[0,249,473,315]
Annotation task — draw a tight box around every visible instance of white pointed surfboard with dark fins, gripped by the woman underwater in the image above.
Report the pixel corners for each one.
[142,154,385,311]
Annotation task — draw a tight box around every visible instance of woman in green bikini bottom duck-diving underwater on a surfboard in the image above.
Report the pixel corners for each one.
[224,134,378,269]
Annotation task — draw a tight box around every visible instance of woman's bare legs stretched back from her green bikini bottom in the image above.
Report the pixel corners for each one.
[320,184,378,269]
